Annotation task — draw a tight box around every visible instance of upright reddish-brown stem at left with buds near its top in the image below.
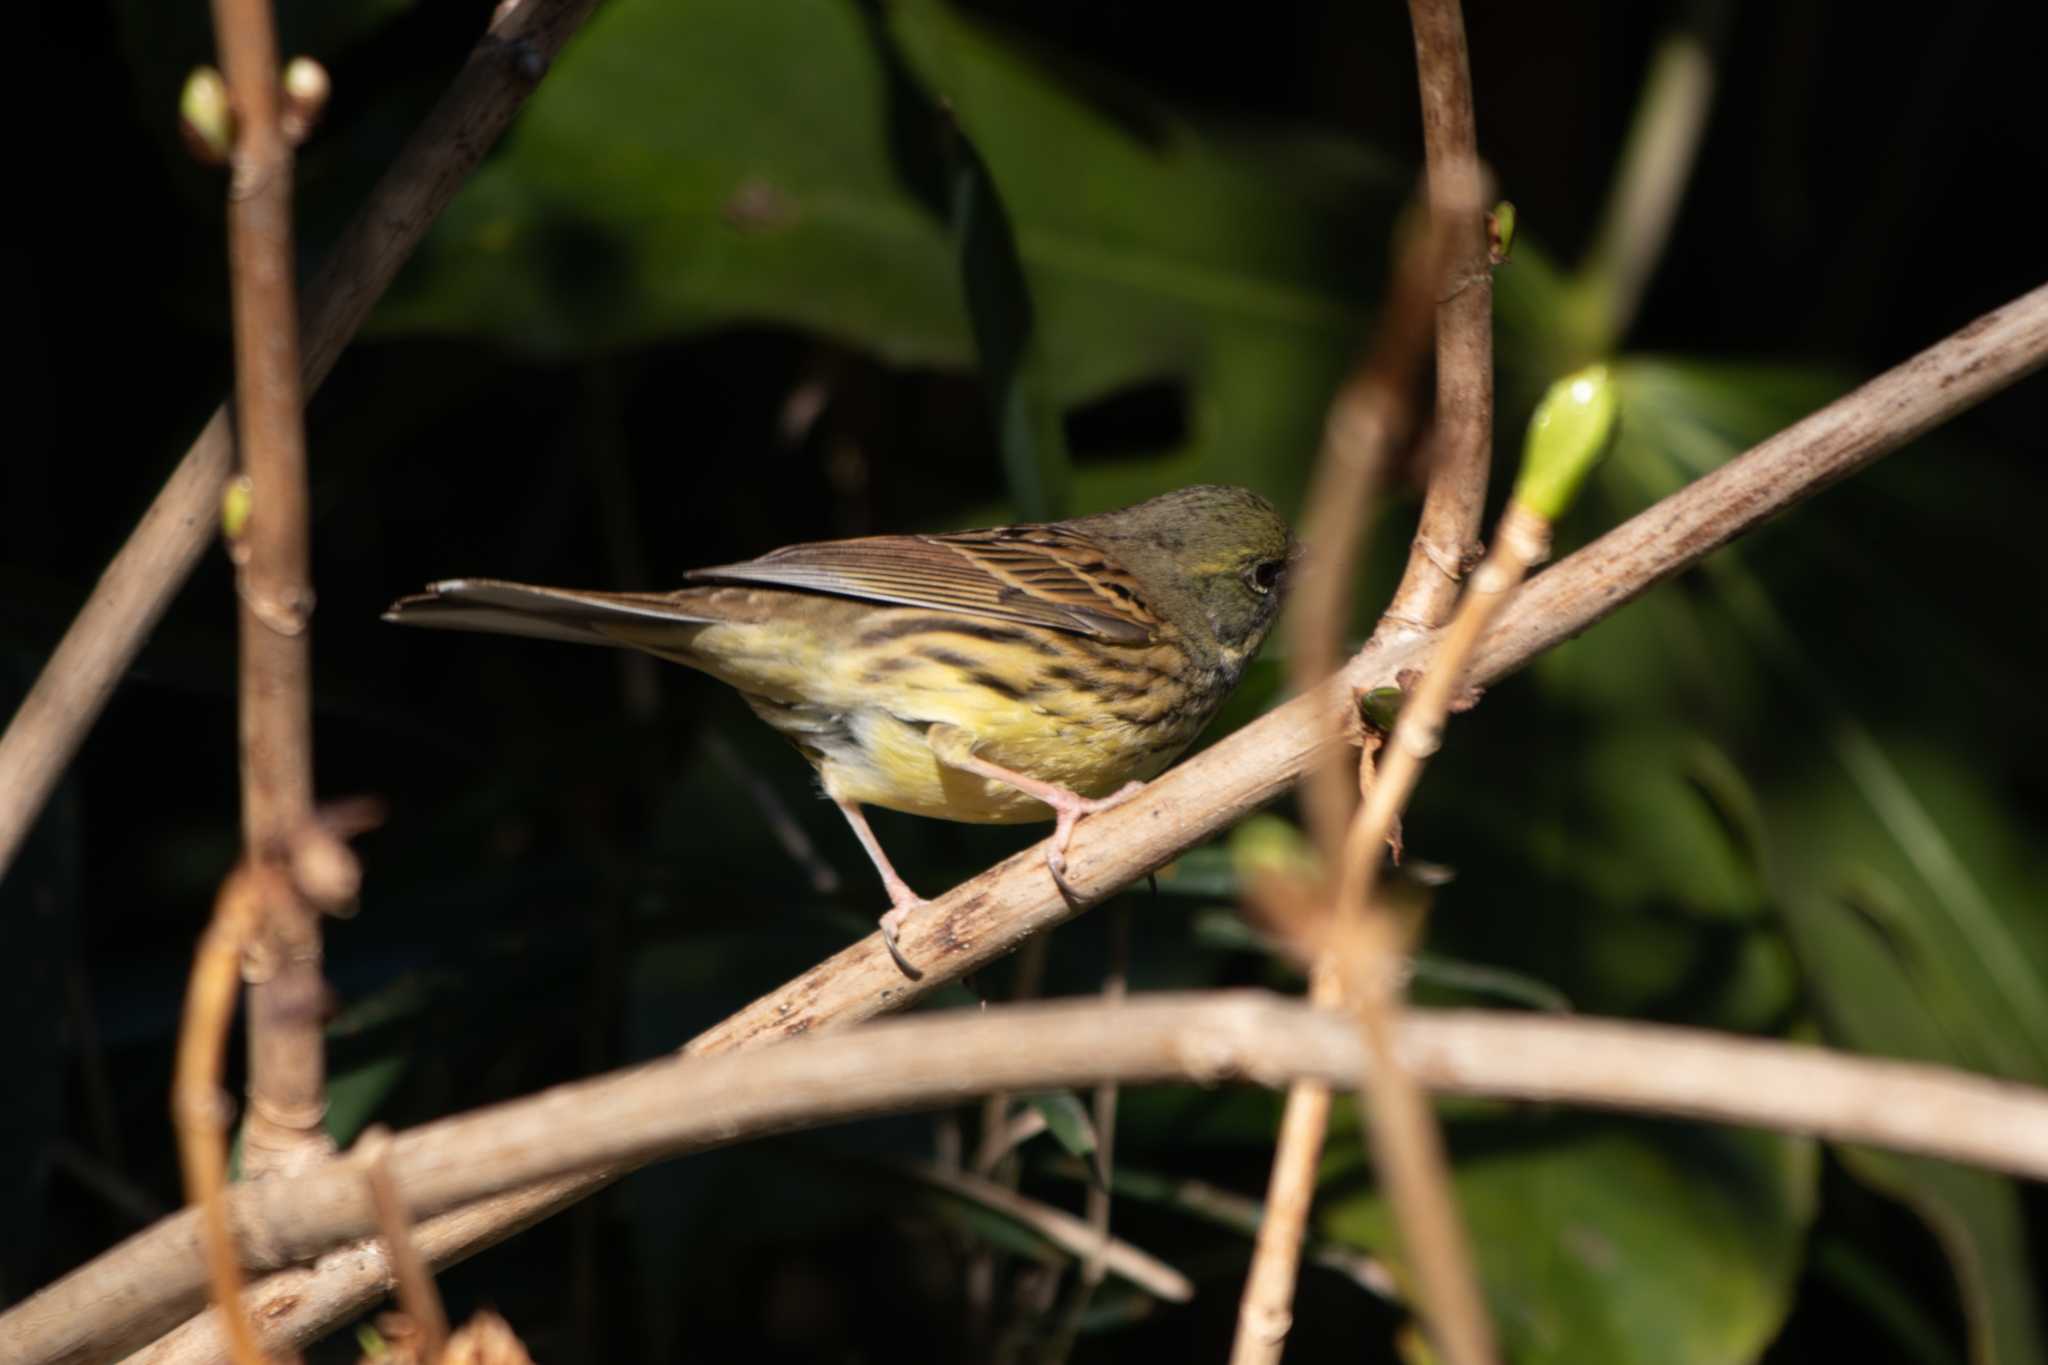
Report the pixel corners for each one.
[213,0,329,1175]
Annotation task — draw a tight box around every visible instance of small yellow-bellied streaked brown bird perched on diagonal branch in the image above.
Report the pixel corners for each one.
[385,485,1300,978]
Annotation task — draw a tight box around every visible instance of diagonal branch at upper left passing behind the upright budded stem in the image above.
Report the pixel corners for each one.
[0,0,598,876]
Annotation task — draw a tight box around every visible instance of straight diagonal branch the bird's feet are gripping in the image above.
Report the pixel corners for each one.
[28,287,2048,1363]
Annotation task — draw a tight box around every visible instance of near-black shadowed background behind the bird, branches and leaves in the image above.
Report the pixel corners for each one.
[0,0,2048,1361]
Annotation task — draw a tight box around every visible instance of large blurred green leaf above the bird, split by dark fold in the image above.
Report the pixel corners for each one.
[379,0,1393,508]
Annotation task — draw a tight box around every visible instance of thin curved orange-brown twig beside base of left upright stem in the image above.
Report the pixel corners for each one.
[170,864,274,1365]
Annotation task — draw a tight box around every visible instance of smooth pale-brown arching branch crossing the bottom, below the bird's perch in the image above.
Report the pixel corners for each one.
[12,990,2048,1365]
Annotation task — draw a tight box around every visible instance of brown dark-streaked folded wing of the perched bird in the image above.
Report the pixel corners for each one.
[690,526,1161,645]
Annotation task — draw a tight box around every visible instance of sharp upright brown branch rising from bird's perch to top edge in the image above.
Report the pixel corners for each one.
[1382,0,1493,630]
